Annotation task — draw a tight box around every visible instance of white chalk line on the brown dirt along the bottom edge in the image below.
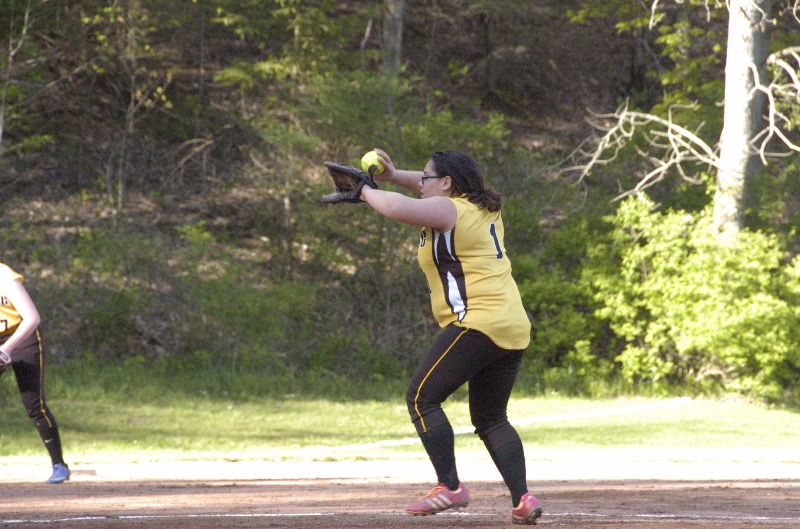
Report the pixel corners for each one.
[0,511,800,525]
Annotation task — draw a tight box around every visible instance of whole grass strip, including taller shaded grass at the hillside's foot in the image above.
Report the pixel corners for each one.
[0,361,800,461]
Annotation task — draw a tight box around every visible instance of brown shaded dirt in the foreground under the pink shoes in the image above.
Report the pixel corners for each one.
[0,472,800,529]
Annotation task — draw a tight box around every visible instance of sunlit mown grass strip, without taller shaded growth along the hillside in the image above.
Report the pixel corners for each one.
[0,388,800,460]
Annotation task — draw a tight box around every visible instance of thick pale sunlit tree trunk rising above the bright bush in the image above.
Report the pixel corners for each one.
[714,0,773,238]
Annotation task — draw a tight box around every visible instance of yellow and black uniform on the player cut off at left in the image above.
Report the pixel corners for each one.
[0,263,64,465]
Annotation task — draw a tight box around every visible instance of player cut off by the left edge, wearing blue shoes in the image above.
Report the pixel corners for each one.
[0,262,70,483]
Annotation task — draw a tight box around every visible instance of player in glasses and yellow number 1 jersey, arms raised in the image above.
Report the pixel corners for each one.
[360,149,542,525]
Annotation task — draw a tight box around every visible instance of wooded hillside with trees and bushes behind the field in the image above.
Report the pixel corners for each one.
[0,0,800,403]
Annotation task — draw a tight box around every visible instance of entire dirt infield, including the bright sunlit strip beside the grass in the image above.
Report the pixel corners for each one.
[0,451,800,529]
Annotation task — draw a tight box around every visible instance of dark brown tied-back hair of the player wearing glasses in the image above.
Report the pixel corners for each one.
[431,151,503,212]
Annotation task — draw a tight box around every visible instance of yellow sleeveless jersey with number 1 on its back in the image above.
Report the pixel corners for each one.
[417,197,531,349]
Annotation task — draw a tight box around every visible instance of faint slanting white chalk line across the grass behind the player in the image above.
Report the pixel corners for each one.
[316,397,692,453]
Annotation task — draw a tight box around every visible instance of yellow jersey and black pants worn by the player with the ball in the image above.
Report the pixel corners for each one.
[406,197,531,472]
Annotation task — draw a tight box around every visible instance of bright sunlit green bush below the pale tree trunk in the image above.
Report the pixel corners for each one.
[587,199,800,399]
